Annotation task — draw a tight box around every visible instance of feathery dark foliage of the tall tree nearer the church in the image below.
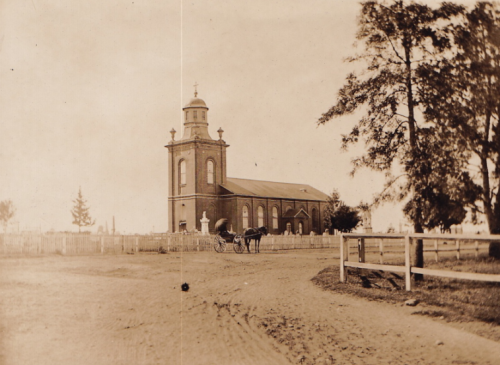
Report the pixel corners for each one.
[318,1,470,232]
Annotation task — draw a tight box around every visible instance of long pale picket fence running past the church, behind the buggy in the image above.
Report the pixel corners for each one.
[0,234,340,255]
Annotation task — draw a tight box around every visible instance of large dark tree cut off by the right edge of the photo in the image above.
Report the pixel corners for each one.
[422,2,500,253]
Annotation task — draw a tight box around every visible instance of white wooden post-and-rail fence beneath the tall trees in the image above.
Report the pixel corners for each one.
[340,233,500,291]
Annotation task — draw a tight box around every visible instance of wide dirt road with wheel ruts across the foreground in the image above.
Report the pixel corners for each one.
[0,250,500,365]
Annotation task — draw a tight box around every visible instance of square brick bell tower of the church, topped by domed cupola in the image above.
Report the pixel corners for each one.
[165,84,229,232]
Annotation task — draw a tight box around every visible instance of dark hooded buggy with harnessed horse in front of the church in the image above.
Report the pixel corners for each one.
[214,218,267,253]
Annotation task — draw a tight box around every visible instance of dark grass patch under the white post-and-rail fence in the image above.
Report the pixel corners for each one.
[312,256,500,325]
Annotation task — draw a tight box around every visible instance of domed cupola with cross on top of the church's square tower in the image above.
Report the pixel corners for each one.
[182,83,212,140]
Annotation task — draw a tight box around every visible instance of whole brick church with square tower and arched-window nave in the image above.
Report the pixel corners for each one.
[165,91,327,234]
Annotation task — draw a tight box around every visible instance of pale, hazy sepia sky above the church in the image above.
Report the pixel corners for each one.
[0,0,476,234]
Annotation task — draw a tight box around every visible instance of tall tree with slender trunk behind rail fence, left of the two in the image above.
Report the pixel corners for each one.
[318,1,463,267]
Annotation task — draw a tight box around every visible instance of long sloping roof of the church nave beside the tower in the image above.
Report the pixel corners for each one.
[221,177,328,200]
